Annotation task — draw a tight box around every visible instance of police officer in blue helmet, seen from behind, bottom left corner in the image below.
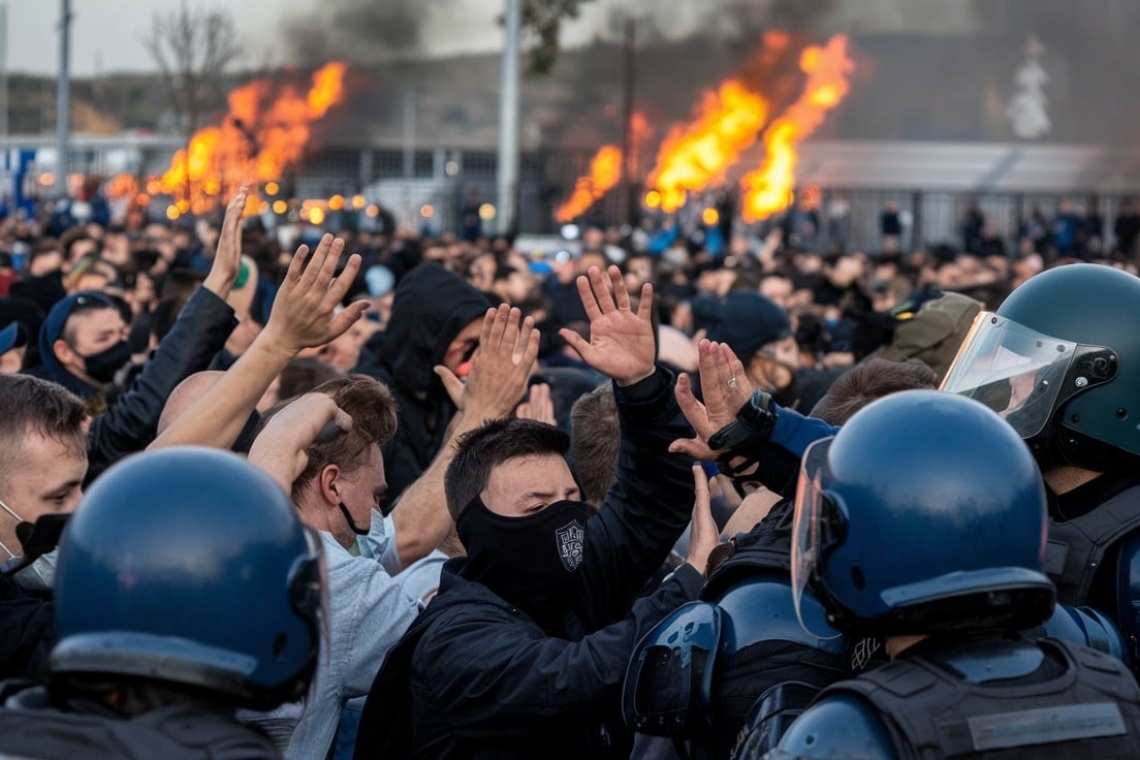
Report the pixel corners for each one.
[0,448,324,760]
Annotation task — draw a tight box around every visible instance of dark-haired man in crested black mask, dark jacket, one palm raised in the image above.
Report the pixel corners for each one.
[356,267,716,758]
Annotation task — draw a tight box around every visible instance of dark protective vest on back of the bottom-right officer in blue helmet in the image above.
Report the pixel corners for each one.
[816,639,1140,760]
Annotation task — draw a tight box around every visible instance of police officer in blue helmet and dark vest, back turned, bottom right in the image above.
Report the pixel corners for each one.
[767,391,1140,759]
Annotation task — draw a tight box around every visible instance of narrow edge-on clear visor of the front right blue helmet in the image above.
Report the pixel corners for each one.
[791,438,844,639]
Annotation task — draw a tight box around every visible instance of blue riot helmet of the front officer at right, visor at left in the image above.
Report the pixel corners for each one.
[792,391,1056,636]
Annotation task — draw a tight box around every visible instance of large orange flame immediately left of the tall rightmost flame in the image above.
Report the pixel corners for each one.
[648,80,768,212]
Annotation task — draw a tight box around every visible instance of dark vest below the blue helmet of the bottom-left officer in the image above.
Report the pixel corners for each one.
[0,689,282,760]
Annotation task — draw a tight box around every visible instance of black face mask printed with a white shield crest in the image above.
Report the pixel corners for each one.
[456,497,591,612]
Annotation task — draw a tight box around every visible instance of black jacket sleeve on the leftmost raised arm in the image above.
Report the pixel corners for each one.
[87,287,237,483]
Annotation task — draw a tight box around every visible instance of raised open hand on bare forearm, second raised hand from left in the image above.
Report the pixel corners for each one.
[263,235,368,358]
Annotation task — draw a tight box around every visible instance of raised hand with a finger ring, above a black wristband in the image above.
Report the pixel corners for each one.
[669,341,752,459]
